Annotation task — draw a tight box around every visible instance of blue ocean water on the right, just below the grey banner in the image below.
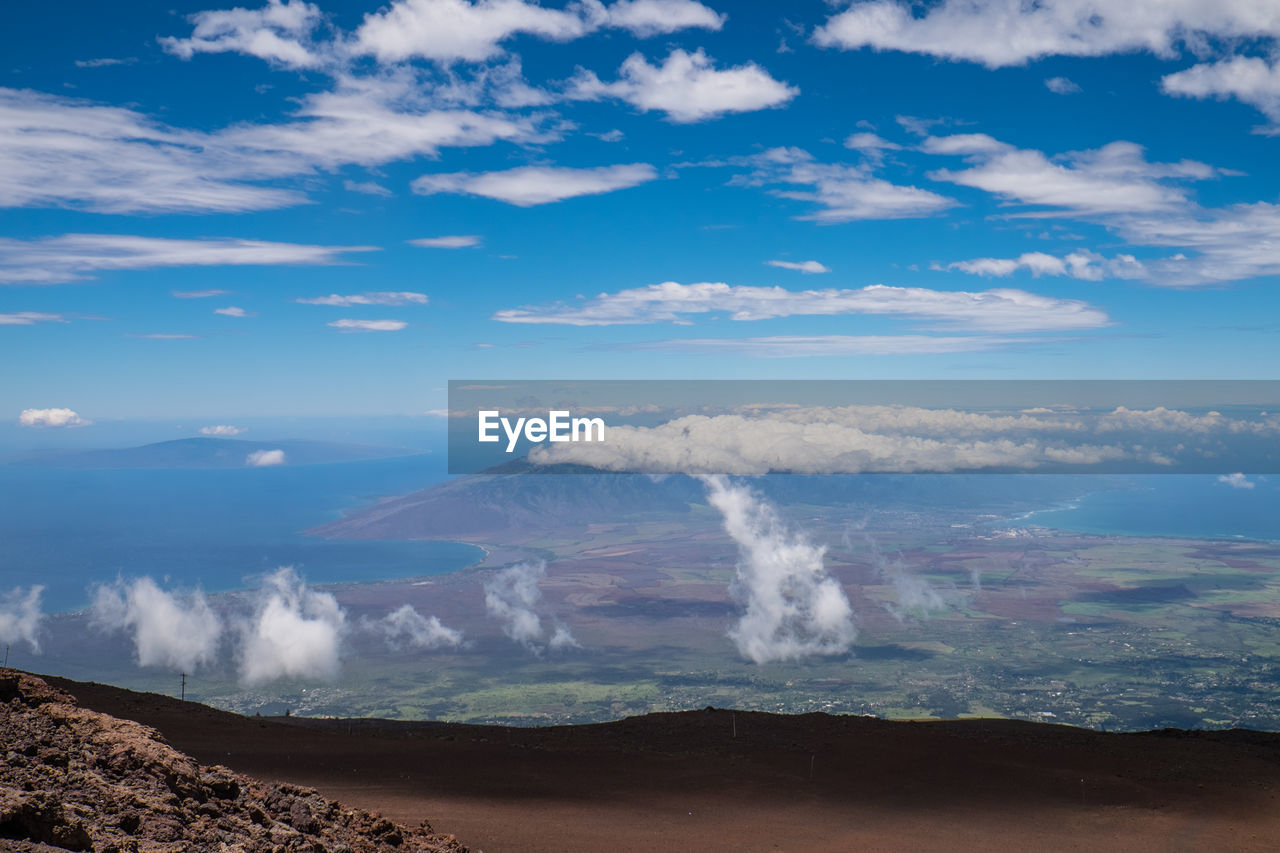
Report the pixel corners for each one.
[1015,474,1280,542]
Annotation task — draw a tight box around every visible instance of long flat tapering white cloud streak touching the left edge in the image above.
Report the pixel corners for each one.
[0,234,374,285]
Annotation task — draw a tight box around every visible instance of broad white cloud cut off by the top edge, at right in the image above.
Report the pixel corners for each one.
[813,0,1280,68]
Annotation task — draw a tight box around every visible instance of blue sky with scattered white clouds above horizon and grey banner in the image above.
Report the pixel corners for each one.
[0,0,1280,425]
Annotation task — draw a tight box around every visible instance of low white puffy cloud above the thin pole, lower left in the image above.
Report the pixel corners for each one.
[90,578,223,672]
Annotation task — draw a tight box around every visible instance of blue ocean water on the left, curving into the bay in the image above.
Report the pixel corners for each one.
[0,455,483,612]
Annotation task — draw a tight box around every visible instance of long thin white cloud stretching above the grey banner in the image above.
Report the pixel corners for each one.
[493,282,1110,332]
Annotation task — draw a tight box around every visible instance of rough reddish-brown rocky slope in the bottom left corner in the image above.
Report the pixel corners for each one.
[0,670,466,853]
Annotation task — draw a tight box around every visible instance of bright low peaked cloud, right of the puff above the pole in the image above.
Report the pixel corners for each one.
[239,566,347,685]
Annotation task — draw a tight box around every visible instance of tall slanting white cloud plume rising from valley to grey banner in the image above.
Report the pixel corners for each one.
[703,476,858,663]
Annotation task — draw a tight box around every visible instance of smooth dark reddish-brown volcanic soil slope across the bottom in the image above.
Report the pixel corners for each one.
[49,679,1280,853]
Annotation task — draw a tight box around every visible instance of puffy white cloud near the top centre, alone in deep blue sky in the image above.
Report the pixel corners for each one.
[567,49,800,123]
